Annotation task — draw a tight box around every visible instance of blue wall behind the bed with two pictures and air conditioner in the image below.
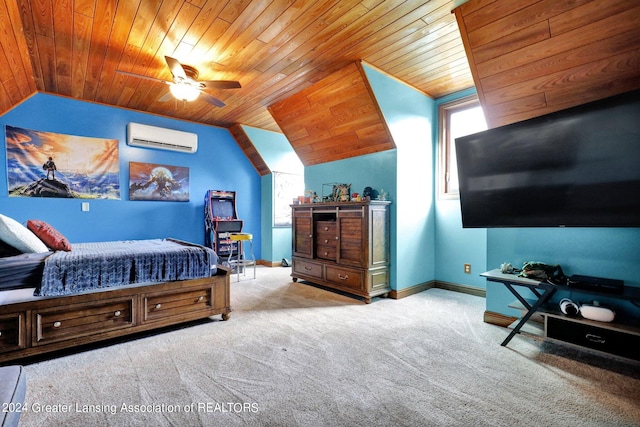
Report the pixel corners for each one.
[0,94,261,258]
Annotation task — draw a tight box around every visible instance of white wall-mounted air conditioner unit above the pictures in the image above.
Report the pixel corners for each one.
[127,123,198,153]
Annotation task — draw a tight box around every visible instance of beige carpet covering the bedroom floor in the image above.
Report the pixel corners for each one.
[16,268,640,427]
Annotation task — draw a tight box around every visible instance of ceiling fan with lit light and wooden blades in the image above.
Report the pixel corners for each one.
[116,56,242,107]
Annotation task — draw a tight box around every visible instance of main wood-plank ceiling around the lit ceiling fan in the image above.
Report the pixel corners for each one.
[0,0,473,131]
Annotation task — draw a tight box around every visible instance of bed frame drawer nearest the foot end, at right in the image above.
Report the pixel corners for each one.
[142,286,213,322]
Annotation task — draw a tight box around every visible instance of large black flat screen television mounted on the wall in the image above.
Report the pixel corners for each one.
[455,90,640,228]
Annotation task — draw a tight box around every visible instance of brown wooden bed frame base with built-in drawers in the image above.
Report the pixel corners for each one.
[0,266,232,363]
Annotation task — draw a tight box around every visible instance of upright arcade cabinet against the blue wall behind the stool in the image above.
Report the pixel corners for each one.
[204,190,244,259]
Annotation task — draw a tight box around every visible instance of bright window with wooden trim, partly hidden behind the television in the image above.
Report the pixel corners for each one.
[438,95,487,199]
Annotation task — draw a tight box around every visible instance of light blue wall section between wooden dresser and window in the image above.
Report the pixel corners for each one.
[363,64,437,290]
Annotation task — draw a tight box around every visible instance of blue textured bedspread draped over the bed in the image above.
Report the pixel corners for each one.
[34,239,218,296]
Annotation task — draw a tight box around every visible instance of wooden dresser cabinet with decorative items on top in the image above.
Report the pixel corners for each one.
[291,201,391,304]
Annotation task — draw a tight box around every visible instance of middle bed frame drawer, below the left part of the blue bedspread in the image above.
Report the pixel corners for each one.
[32,297,134,346]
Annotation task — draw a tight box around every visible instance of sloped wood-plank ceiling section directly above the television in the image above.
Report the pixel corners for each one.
[455,0,640,127]
